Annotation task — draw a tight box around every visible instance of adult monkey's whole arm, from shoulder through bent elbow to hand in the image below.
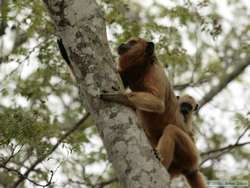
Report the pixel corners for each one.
[101,65,167,113]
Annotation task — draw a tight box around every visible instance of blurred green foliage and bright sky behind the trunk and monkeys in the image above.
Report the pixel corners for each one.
[0,0,250,188]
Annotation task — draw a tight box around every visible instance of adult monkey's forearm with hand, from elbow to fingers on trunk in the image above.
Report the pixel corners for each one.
[101,92,165,113]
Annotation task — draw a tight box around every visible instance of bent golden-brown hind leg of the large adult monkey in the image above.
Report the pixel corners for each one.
[157,125,207,188]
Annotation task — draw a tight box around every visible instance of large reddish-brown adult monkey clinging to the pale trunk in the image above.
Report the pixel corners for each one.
[101,38,206,188]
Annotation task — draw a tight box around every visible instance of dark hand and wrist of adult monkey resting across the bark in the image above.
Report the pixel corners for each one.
[100,92,134,108]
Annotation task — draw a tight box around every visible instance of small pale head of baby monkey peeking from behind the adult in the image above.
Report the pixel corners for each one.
[177,95,199,117]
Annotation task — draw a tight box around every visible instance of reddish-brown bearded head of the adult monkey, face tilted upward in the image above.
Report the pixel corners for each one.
[117,38,154,72]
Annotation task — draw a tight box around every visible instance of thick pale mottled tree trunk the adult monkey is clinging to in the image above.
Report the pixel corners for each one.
[44,0,172,188]
